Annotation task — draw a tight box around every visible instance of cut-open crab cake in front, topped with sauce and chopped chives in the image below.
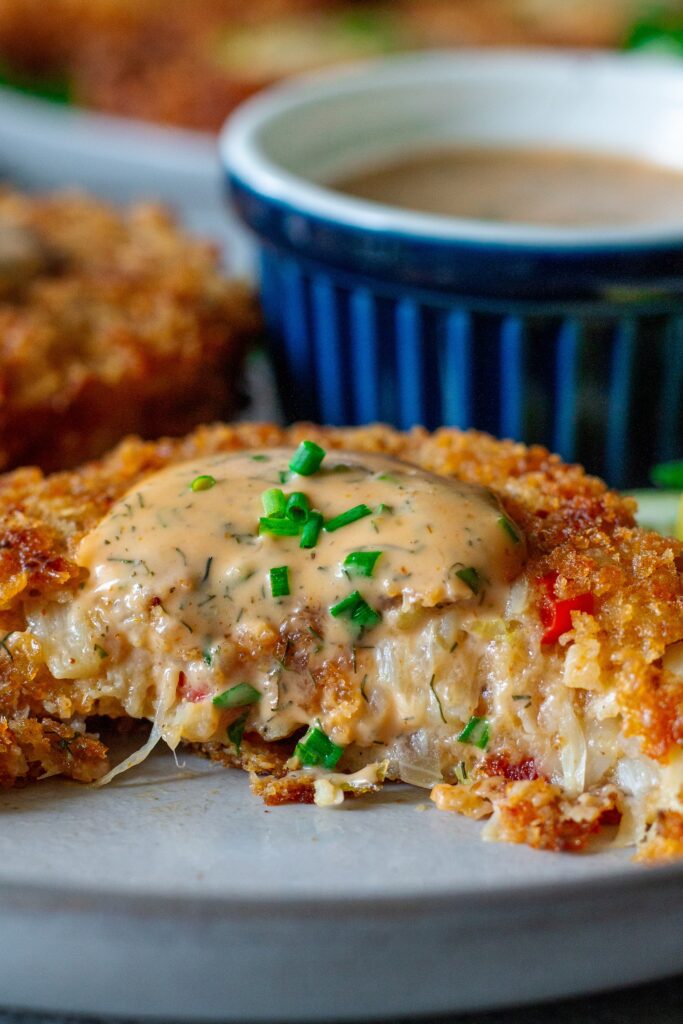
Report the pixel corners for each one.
[0,424,683,859]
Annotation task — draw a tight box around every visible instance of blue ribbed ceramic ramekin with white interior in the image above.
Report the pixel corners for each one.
[221,51,683,485]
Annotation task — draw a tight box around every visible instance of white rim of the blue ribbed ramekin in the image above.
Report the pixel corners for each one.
[219,49,683,252]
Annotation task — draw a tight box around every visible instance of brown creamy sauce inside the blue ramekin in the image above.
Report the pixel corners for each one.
[333,148,683,227]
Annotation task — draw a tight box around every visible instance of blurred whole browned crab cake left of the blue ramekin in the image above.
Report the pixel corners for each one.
[0,189,259,470]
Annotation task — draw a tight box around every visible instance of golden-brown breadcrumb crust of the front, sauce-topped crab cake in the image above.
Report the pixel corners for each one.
[0,424,683,856]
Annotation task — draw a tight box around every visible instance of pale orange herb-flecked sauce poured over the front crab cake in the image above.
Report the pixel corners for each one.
[28,450,525,770]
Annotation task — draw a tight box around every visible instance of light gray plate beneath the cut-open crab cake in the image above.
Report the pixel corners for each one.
[0,754,683,1021]
